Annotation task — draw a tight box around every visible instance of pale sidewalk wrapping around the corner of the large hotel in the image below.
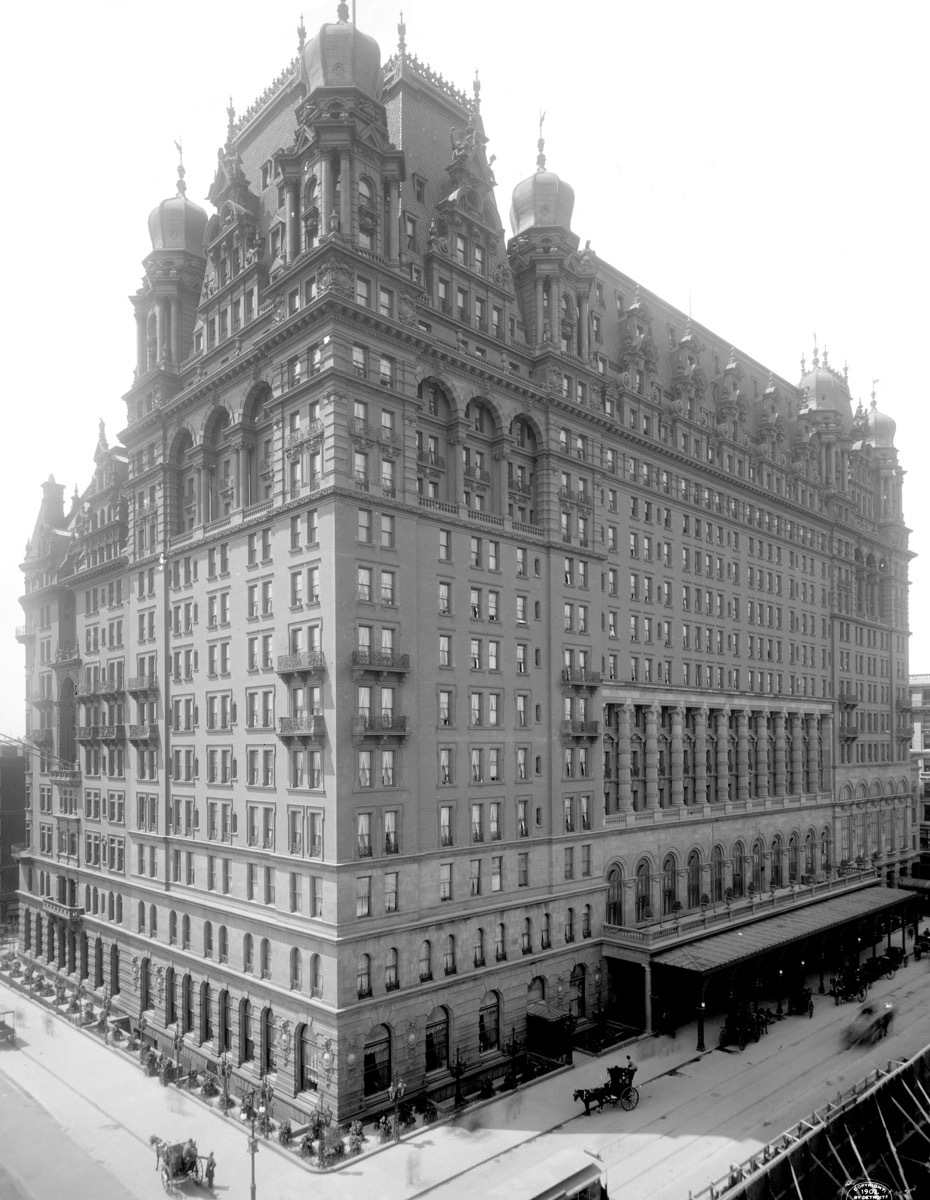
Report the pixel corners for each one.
[0,984,698,1200]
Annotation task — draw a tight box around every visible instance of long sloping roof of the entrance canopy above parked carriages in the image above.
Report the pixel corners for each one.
[653,887,913,974]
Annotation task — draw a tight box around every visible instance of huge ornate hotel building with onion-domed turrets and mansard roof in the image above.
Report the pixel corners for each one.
[12,5,916,1118]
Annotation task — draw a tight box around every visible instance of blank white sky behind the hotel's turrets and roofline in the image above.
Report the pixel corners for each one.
[0,0,930,736]
